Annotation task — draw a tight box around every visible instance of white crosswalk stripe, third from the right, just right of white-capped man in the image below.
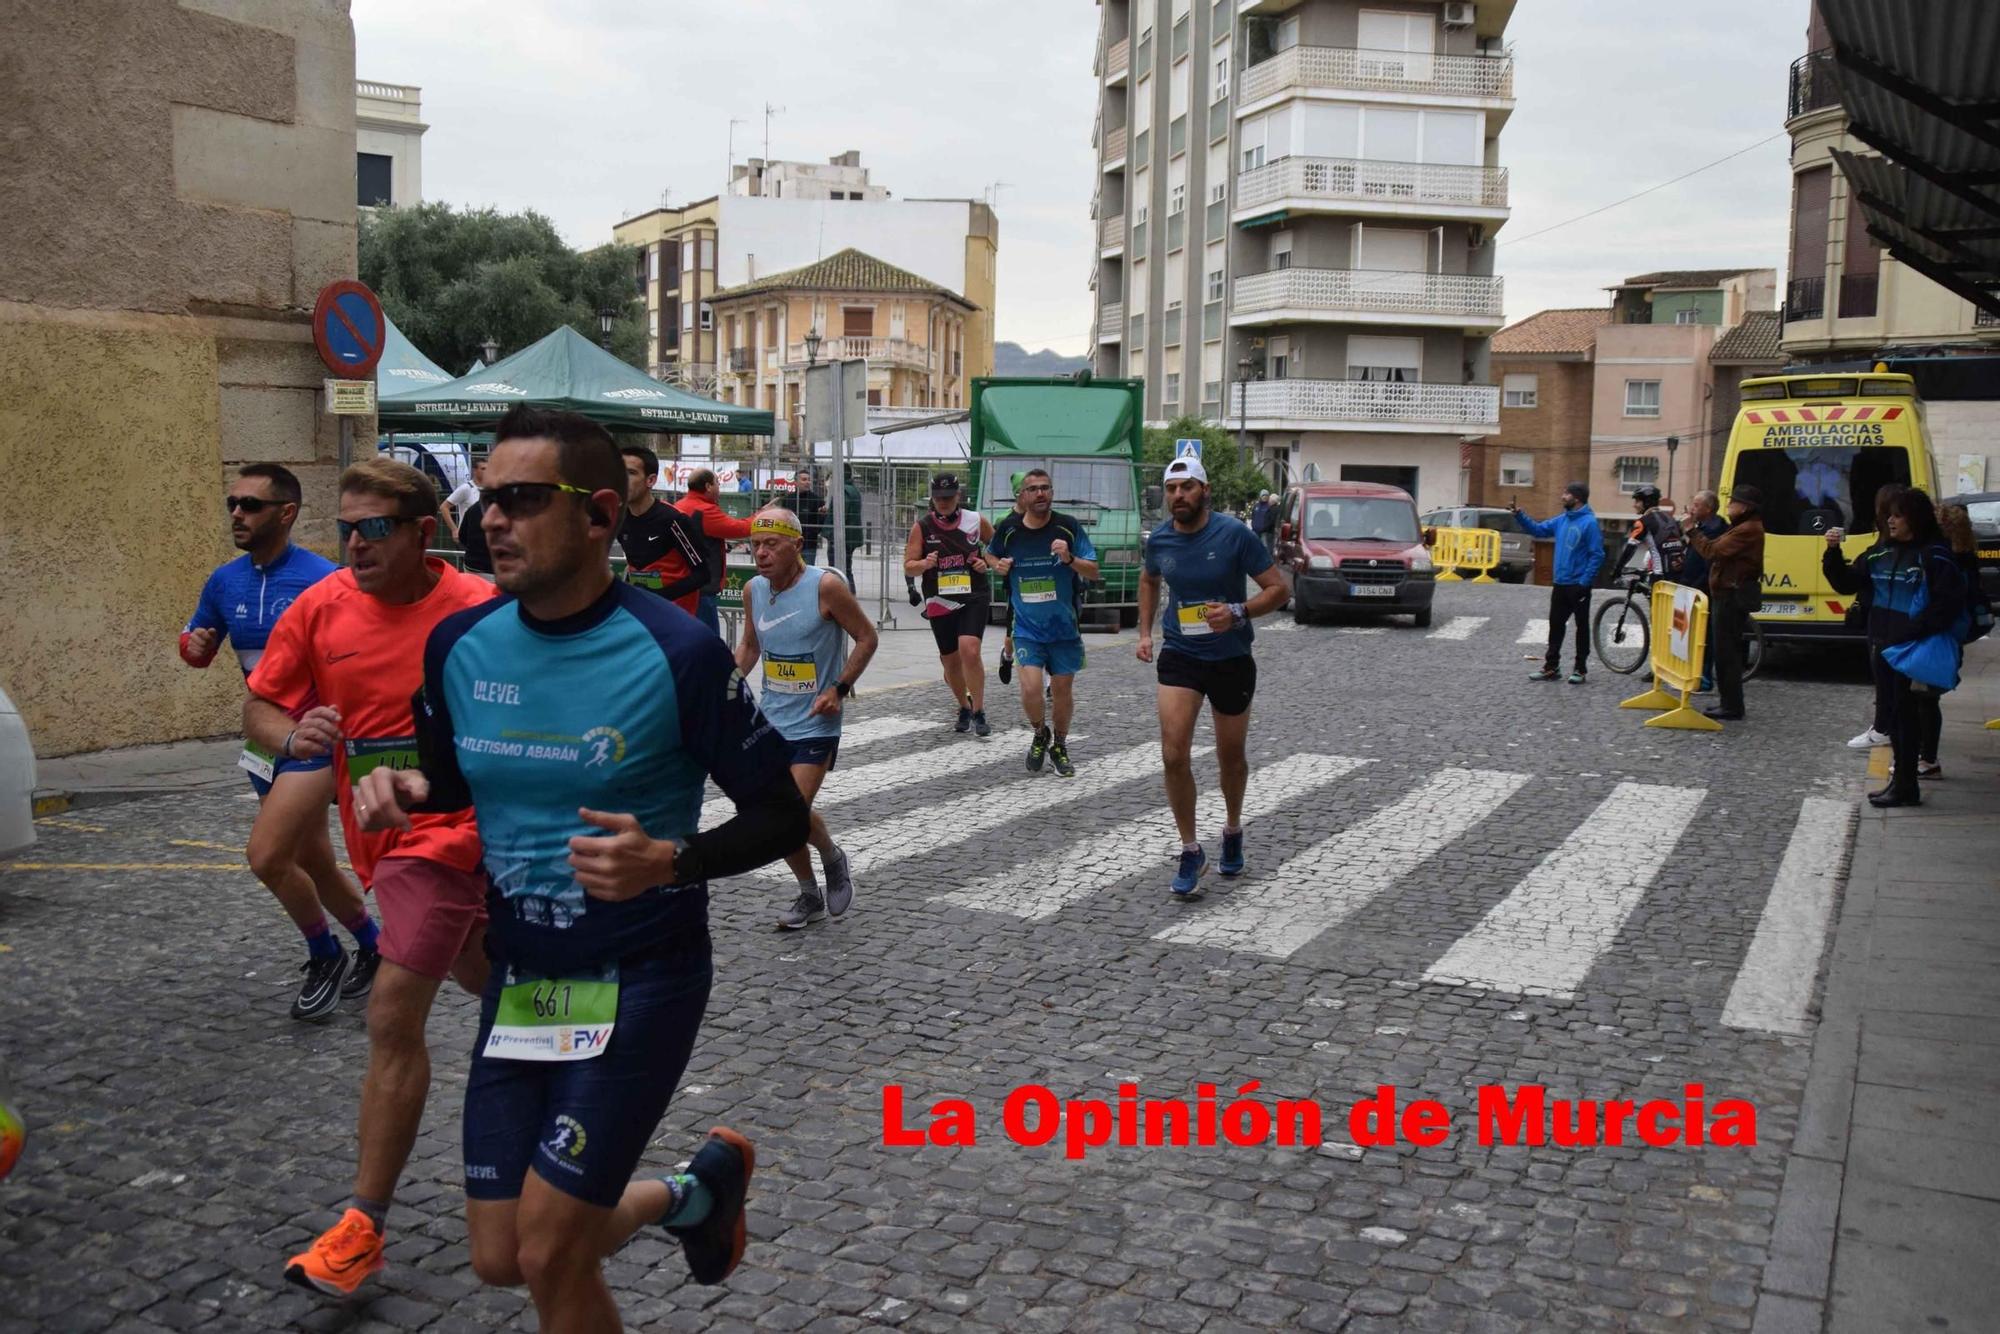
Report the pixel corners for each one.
[1154,768,1528,958]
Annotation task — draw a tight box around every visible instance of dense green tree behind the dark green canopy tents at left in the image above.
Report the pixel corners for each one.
[360,204,646,374]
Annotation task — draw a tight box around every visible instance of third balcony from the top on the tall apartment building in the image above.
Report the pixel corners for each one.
[1230,268,1504,328]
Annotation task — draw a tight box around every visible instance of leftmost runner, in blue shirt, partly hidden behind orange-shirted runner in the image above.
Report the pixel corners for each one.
[180,464,382,1022]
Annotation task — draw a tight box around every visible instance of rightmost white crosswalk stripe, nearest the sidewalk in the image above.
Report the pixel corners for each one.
[1722,796,1854,1034]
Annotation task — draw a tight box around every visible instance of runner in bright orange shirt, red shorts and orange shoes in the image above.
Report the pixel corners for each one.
[244,458,494,1296]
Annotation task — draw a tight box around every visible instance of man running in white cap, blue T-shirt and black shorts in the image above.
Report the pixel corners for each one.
[1138,458,1284,898]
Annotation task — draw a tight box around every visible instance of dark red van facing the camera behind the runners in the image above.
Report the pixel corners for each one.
[1272,482,1436,626]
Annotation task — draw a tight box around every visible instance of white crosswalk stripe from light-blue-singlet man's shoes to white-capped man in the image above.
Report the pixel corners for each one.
[754,740,1184,880]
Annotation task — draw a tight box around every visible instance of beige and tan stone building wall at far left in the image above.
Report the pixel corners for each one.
[0,0,374,756]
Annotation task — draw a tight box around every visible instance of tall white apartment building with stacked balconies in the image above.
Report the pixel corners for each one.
[1092,0,1514,506]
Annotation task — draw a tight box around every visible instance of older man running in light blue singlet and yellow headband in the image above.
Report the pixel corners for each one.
[736,508,876,930]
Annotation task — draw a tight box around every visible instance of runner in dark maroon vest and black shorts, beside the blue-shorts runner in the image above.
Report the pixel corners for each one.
[902,472,994,736]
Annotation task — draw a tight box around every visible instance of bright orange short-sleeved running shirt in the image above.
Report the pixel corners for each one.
[250,556,498,884]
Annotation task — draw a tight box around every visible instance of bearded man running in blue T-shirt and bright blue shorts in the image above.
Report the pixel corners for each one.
[988,468,1098,778]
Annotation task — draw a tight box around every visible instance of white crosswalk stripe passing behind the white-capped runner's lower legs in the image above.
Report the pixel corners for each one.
[930,754,1372,922]
